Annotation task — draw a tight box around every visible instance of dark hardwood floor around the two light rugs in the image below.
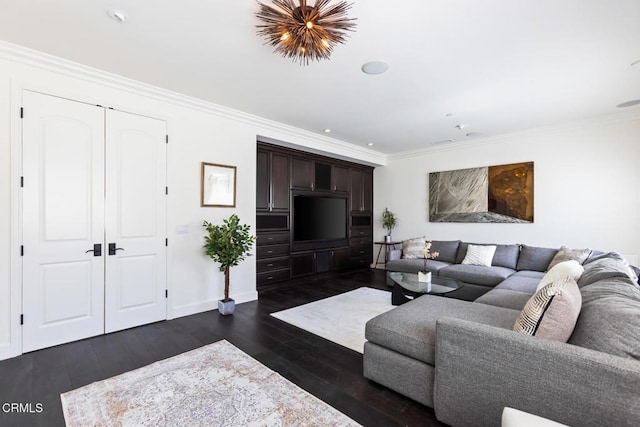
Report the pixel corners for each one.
[0,270,442,426]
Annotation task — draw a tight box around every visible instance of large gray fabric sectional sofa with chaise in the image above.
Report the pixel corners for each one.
[363,241,640,426]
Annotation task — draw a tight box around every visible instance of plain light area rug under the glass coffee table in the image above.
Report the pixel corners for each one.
[271,288,394,353]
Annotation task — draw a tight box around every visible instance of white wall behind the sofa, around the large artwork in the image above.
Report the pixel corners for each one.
[374,115,640,265]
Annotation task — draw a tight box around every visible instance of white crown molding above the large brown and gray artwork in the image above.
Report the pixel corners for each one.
[387,108,640,161]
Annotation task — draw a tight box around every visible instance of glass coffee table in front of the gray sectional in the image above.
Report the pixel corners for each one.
[387,271,463,305]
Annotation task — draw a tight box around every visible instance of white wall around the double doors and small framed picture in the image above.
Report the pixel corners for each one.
[0,42,384,359]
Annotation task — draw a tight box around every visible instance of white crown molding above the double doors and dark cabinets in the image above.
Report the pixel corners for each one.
[0,40,387,165]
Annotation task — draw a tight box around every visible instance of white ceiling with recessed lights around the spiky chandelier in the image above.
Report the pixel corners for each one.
[0,0,640,153]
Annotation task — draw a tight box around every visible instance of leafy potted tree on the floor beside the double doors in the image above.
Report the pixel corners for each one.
[202,214,256,315]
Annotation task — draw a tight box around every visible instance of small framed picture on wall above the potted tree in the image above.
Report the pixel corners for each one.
[200,162,236,208]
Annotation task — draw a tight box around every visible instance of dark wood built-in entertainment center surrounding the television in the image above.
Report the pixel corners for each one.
[256,141,373,290]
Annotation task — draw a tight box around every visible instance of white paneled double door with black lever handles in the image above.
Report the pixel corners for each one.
[22,91,167,352]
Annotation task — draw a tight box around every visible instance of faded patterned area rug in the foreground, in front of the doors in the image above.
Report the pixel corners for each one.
[61,341,358,426]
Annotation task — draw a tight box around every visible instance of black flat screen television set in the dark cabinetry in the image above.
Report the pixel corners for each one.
[293,194,347,242]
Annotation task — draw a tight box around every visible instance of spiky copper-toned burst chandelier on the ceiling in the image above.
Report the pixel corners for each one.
[256,0,356,65]
